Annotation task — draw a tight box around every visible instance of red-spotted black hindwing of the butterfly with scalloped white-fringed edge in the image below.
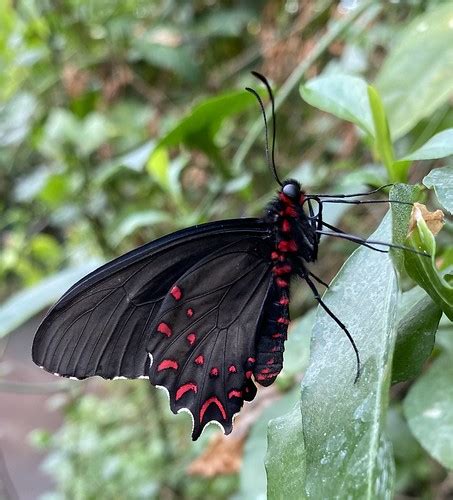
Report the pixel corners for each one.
[147,237,273,439]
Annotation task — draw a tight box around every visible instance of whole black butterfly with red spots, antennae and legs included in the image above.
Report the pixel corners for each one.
[33,73,420,440]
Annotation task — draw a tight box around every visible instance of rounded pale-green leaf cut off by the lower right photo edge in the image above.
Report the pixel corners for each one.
[404,353,453,469]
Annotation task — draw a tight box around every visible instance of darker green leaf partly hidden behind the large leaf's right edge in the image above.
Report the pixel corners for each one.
[392,286,442,384]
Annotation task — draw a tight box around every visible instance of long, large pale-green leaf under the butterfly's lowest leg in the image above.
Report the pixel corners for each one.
[298,215,398,499]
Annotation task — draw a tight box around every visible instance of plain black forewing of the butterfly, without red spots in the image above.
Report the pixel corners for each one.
[32,219,269,378]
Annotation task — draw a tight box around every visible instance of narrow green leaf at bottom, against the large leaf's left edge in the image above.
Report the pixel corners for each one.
[266,404,305,500]
